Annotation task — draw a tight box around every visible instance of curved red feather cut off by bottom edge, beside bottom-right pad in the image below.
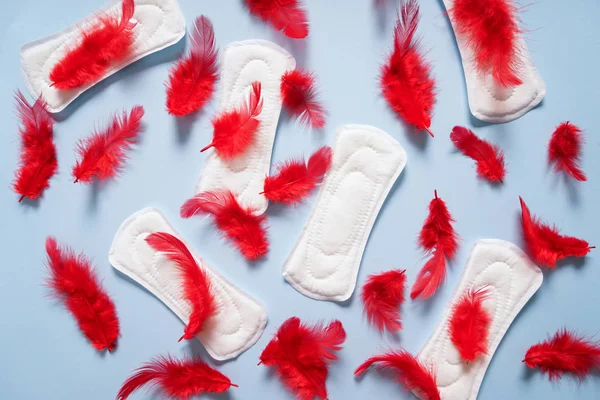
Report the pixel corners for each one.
[354,350,440,400]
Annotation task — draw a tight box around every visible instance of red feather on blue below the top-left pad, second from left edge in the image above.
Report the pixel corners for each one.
[73,106,144,183]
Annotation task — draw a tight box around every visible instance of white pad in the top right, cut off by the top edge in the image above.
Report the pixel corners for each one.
[443,0,546,123]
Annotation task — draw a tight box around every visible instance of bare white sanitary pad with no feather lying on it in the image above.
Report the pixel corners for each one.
[283,125,406,301]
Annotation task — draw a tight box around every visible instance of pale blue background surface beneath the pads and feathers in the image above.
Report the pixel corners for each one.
[0,0,600,400]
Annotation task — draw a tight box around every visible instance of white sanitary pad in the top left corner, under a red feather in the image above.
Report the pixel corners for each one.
[21,0,185,113]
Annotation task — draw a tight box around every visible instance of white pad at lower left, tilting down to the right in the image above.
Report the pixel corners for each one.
[108,208,267,360]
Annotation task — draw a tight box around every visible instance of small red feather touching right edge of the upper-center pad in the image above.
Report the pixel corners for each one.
[281,70,327,128]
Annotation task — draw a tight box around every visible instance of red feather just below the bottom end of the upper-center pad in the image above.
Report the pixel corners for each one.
[180,190,269,260]
